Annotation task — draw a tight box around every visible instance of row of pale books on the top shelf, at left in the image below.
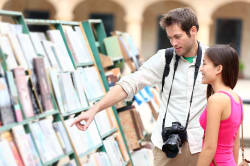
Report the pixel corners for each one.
[0,22,93,71]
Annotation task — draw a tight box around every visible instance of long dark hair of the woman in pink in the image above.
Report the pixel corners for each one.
[206,45,239,98]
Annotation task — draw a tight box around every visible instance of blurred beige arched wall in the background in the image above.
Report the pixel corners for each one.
[0,0,250,78]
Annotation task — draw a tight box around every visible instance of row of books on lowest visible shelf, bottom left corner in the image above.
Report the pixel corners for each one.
[0,119,66,166]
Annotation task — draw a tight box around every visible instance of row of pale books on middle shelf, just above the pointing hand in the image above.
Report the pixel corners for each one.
[50,67,105,114]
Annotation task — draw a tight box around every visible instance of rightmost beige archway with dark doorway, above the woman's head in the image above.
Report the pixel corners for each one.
[210,2,250,77]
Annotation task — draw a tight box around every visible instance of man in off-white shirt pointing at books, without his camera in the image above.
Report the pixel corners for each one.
[72,8,206,166]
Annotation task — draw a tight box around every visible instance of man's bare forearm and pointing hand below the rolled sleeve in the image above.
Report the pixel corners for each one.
[71,85,128,131]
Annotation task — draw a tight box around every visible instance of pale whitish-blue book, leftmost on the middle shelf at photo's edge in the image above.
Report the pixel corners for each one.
[0,77,15,125]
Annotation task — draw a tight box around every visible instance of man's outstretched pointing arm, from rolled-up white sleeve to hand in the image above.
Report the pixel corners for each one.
[71,50,165,130]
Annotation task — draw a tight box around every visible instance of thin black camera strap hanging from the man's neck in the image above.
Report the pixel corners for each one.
[162,42,202,130]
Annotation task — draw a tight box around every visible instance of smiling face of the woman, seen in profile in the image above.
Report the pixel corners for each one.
[200,54,218,84]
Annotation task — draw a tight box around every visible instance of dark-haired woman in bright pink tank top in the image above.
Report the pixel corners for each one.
[197,45,241,166]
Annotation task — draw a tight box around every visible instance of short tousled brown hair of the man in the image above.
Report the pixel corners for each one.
[160,8,199,35]
